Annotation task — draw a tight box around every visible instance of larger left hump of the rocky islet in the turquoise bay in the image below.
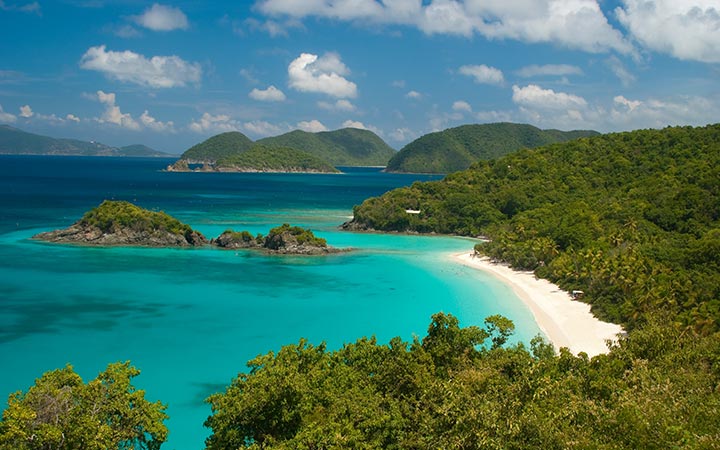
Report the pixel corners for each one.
[33,200,208,247]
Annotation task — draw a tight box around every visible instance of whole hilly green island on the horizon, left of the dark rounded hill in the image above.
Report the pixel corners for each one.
[168,128,395,173]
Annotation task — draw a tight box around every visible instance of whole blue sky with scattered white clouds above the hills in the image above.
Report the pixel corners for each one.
[0,0,720,153]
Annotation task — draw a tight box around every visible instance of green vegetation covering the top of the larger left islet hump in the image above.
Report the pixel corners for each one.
[80,200,193,236]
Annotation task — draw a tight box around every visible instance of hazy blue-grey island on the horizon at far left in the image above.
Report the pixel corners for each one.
[0,125,172,157]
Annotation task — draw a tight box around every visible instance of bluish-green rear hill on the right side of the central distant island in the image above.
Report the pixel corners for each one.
[257,128,396,166]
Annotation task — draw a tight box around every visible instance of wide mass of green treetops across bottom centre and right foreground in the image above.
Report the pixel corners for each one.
[206,313,720,449]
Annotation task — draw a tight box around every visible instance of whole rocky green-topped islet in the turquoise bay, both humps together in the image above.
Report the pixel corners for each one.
[33,200,347,255]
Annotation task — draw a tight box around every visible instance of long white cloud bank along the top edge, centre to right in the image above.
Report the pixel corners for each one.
[256,0,632,54]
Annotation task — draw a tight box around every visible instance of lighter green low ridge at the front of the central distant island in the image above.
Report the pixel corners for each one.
[215,145,339,173]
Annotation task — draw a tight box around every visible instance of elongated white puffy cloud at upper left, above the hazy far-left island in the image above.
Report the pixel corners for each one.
[80,45,202,88]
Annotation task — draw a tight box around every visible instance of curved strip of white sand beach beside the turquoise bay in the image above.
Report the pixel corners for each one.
[454,253,623,357]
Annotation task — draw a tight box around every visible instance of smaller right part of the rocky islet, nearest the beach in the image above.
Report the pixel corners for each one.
[212,224,347,255]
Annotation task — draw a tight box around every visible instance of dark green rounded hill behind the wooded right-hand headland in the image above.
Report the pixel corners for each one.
[386,123,599,173]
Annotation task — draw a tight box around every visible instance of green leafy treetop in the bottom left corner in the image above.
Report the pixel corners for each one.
[0,363,167,450]
